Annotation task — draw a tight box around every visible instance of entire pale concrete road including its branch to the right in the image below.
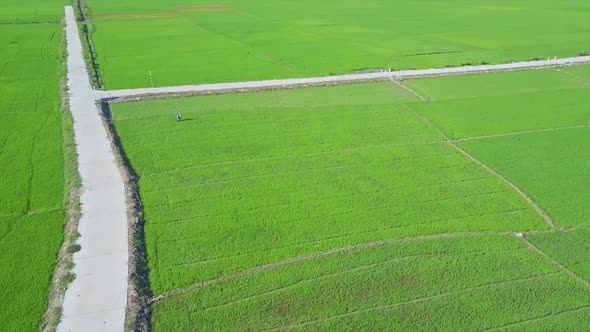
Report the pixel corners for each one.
[58,6,590,332]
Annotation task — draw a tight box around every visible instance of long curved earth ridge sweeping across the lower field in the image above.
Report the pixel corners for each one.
[148,230,555,304]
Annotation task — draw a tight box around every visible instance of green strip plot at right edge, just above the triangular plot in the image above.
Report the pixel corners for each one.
[415,86,590,139]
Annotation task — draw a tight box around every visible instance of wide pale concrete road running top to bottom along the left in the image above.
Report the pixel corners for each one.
[58,6,128,332]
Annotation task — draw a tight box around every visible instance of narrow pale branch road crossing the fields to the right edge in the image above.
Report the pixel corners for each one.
[102,56,590,99]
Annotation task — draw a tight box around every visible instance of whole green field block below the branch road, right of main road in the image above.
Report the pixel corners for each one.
[111,66,590,331]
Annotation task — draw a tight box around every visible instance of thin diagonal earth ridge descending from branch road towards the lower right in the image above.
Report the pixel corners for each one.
[397,82,556,229]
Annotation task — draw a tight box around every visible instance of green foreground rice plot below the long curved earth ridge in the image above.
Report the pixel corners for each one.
[153,236,590,331]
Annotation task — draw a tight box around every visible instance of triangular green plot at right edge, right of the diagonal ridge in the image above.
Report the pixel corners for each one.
[461,128,590,227]
